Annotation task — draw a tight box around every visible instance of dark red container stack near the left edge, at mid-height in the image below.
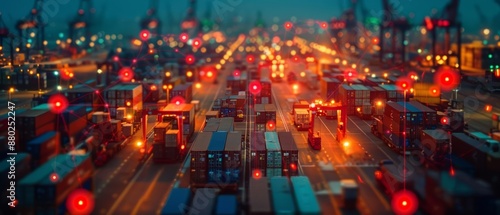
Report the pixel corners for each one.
[16,110,56,151]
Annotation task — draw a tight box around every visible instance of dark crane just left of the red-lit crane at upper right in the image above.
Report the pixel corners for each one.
[379,0,411,66]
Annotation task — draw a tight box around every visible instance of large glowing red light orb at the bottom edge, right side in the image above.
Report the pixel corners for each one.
[391,190,418,215]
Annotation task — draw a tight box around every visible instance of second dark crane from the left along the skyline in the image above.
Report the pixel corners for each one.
[68,0,95,49]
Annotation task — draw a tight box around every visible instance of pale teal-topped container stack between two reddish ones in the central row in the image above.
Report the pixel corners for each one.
[265,132,283,177]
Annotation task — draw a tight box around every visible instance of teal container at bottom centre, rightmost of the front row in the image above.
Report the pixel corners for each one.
[290,176,321,215]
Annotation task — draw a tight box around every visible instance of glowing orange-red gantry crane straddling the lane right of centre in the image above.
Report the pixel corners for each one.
[307,103,347,150]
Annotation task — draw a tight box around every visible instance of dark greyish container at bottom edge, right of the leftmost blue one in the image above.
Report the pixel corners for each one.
[187,188,219,215]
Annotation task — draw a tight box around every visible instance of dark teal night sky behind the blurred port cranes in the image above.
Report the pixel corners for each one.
[0,0,500,37]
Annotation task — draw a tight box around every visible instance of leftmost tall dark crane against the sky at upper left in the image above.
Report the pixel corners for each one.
[16,0,45,53]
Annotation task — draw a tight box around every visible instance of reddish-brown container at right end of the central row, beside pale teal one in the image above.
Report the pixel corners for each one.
[278,132,299,177]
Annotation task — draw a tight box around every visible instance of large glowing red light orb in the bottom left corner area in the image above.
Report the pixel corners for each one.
[66,189,94,214]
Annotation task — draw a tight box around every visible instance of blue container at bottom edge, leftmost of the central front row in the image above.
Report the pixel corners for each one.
[160,187,192,215]
